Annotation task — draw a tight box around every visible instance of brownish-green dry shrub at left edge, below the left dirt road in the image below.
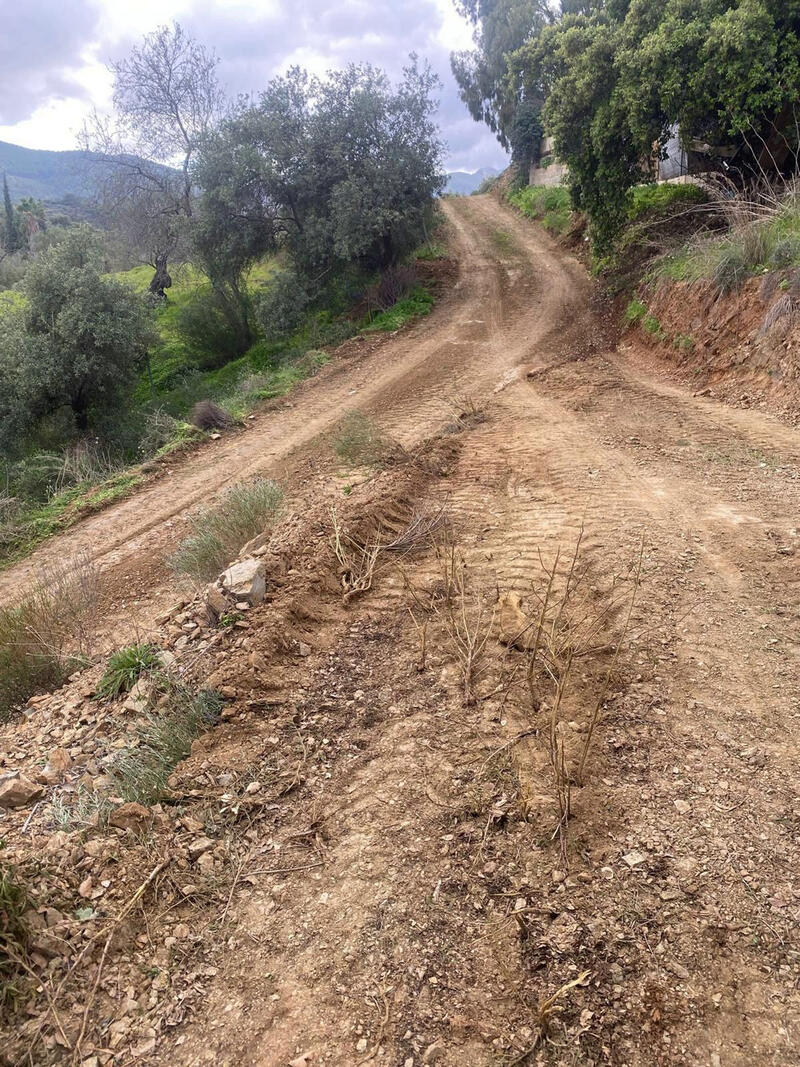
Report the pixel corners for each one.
[0,556,97,721]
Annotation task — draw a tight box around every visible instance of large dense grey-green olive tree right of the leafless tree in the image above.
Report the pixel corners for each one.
[193,57,444,352]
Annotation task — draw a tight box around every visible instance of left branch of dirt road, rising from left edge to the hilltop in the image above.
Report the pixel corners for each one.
[0,200,588,632]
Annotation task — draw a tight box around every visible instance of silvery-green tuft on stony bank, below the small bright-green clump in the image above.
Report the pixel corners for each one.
[110,681,223,805]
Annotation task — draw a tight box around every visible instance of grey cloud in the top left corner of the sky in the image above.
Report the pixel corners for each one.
[0,0,98,125]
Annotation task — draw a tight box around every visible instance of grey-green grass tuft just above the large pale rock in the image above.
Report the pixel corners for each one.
[170,479,283,583]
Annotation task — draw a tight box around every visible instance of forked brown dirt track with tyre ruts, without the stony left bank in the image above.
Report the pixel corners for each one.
[0,197,800,1067]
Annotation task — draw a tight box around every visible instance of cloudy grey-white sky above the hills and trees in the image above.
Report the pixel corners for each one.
[0,0,506,171]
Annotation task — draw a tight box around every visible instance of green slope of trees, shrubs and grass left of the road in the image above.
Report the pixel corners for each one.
[0,26,444,566]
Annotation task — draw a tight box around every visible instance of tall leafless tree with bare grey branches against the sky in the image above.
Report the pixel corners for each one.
[81,22,224,298]
